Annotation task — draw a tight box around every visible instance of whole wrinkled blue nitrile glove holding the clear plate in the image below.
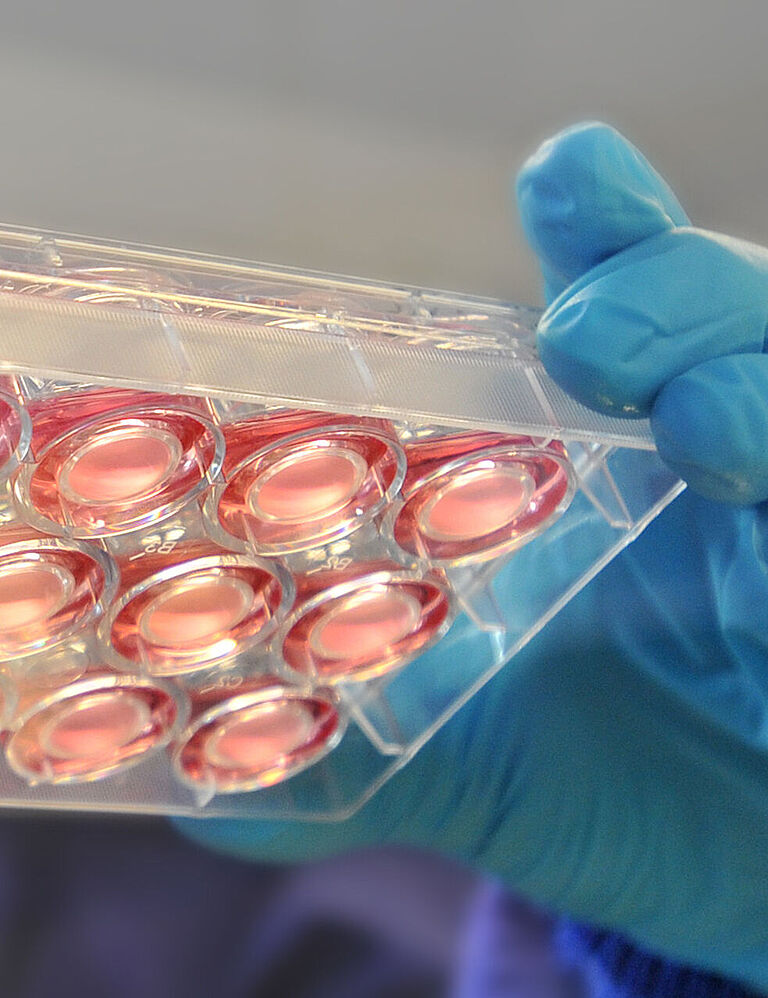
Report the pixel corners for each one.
[183,125,768,990]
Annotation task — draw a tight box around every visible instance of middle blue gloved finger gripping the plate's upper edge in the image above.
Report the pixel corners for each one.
[537,229,768,416]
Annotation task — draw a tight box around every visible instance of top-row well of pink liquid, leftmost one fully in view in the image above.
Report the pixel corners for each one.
[25,389,221,537]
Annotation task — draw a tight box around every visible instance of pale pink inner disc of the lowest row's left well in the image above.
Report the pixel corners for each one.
[41,690,150,760]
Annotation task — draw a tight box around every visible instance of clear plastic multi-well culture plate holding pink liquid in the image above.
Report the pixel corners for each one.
[0,228,681,819]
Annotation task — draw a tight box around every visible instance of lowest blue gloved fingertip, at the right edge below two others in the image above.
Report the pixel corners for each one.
[651,354,768,506]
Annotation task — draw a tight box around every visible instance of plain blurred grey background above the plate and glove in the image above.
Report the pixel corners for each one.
[0,0,768,302]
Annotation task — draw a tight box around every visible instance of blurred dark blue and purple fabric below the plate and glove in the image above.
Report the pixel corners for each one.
[0,815,747,998]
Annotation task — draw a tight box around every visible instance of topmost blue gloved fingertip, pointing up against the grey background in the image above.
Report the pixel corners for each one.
[516,122,689,301]
